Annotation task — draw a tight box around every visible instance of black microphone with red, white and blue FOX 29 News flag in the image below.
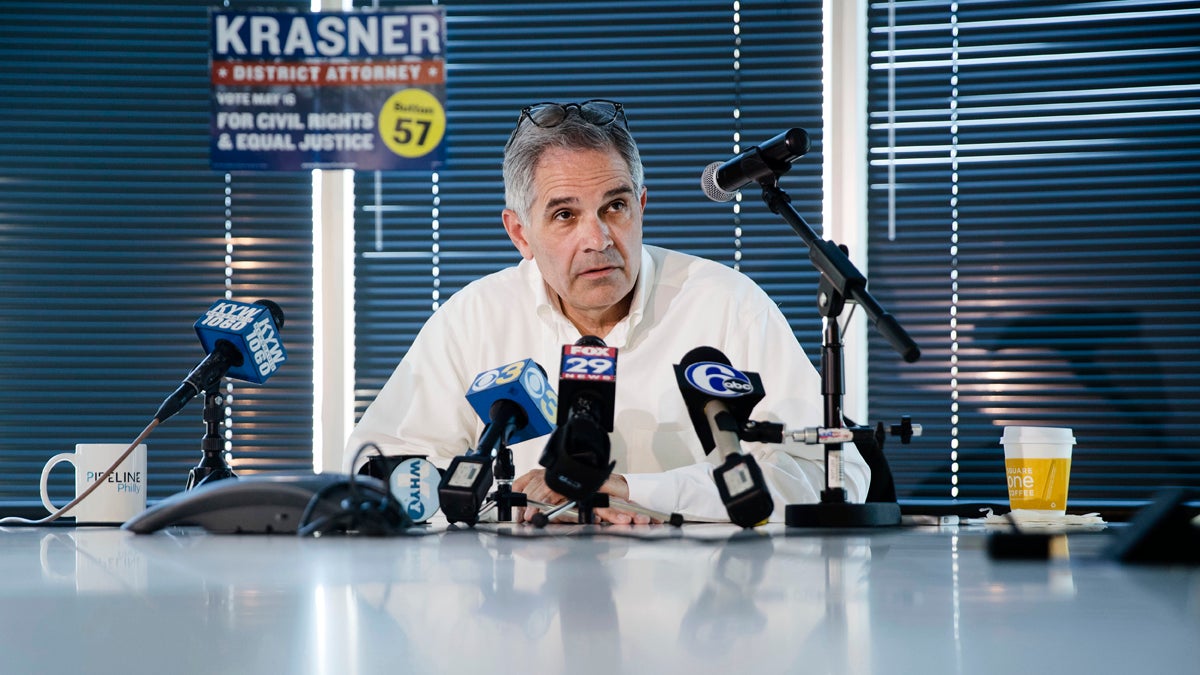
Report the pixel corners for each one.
[538,335,617,502]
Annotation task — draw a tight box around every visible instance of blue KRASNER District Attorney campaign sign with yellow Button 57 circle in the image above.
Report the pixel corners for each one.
[209,6,446,171]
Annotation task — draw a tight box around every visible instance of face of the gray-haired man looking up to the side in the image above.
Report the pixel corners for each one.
[504,148,646,330]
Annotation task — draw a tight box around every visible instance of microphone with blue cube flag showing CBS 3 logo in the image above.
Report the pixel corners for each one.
[438,359,558,525]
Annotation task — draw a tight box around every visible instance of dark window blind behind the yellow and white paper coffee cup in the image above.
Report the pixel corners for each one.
[869,0,1200,506]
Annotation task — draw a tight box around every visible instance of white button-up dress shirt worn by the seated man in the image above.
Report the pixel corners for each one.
[347,246,870,521]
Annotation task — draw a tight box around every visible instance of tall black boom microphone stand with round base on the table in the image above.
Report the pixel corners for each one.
[758,182,920,527]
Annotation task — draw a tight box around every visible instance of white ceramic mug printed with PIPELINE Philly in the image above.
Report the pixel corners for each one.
[42,443,146,524]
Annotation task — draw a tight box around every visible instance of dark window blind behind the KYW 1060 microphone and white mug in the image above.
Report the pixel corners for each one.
[0,0,312,512]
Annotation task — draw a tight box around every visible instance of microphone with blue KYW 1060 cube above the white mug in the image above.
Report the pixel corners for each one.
[155,300,288,423]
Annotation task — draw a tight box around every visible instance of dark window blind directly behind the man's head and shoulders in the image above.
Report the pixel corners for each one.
[355,0,822,422]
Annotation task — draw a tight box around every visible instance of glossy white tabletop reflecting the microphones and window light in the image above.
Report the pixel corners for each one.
[0,525,1200,675]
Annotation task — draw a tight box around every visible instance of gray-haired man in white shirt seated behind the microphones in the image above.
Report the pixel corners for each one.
[347,101,870,524]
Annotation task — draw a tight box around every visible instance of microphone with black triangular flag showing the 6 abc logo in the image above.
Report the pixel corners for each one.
[674,347,775,527]
